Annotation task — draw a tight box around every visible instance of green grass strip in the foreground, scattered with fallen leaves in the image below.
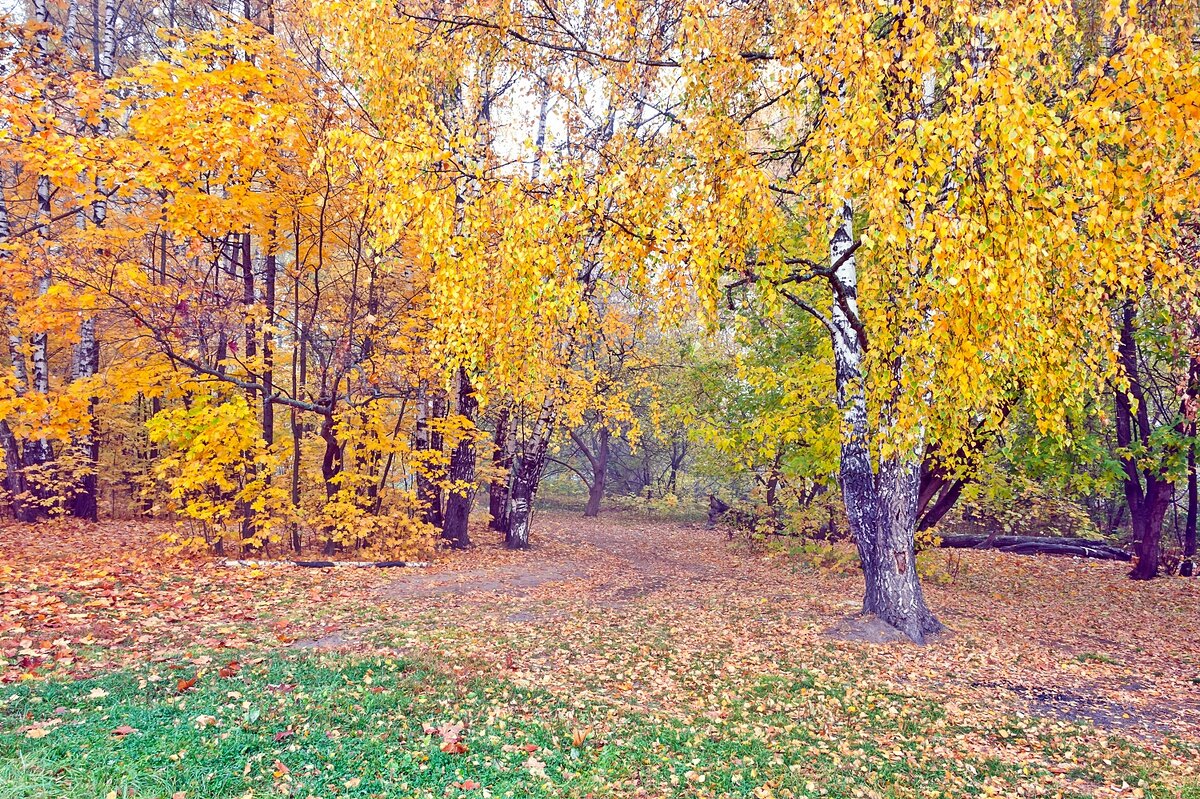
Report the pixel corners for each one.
[0,653,1195,799]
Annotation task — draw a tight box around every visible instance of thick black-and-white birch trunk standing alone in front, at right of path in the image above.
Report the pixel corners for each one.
[829,203,942,643]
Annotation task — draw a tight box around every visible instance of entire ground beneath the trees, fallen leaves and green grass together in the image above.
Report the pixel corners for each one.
[0,512,1200,799]
